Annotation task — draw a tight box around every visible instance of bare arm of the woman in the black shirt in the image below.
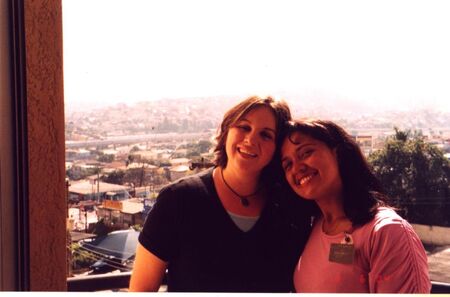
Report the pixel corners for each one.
[129,243,167,292]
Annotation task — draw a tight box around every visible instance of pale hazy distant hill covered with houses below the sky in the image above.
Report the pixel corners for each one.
[66,95,450,139]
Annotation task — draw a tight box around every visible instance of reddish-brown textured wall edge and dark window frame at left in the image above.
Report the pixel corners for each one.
[0,0,68,291]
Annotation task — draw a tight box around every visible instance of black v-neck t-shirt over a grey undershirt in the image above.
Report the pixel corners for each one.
[139,169,310,292]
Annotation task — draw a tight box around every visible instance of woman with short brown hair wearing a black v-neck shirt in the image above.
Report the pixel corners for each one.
[130,97,310,292]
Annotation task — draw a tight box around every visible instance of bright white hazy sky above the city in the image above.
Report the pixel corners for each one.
[63,0,450,111]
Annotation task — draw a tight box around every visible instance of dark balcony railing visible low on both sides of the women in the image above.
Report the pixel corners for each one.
[67,272,450,294]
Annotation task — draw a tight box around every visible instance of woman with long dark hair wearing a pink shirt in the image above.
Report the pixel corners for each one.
[281,120,431,293]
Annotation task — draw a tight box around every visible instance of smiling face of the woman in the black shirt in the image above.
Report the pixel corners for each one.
[225,107,276,174]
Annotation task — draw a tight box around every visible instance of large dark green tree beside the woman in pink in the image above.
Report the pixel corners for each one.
[369,128,450,226]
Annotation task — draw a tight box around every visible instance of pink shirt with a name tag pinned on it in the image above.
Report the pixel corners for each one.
[294,208,431,293]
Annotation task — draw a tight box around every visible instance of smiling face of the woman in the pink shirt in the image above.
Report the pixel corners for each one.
[281,132,342,200]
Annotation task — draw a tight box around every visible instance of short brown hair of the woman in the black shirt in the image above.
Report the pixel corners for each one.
[214,96,291,180]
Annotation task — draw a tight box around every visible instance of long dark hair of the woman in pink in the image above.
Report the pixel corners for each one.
[284,119,387,225]
